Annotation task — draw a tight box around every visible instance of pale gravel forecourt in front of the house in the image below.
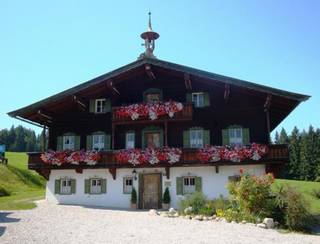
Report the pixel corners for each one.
[0,201,320,244]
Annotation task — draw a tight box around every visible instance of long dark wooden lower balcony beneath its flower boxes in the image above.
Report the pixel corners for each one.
[28,144,289,178]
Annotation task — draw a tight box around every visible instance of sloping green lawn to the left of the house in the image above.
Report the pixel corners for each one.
[0,152,46,210]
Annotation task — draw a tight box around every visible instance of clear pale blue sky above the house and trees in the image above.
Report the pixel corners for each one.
[0,0,320,132]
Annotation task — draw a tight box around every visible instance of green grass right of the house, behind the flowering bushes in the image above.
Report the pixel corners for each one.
[275,179,320,216]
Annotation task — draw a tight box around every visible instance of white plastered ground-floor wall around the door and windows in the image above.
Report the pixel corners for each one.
[46,164,265,208]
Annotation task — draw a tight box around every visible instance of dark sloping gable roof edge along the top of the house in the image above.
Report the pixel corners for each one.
[8,58,310,126]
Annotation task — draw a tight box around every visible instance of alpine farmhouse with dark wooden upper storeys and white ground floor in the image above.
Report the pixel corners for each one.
[9,18,309,209]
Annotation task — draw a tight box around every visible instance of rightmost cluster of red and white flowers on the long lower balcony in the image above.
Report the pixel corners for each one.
[197,143,268,162]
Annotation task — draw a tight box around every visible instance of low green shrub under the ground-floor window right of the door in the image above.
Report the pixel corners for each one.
[179,192,209,214]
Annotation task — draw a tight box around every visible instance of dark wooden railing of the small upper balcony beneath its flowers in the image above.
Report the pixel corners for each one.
[112,103,193,124]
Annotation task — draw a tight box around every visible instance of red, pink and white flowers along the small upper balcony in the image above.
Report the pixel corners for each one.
[115,101,183,120]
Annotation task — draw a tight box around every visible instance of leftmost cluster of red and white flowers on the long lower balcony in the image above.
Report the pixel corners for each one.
[41,150,100,166]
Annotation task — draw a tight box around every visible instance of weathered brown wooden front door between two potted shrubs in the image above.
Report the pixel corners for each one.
[141,173,161,209]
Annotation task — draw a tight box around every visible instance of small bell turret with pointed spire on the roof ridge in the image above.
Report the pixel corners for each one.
[139,12,160,59]
